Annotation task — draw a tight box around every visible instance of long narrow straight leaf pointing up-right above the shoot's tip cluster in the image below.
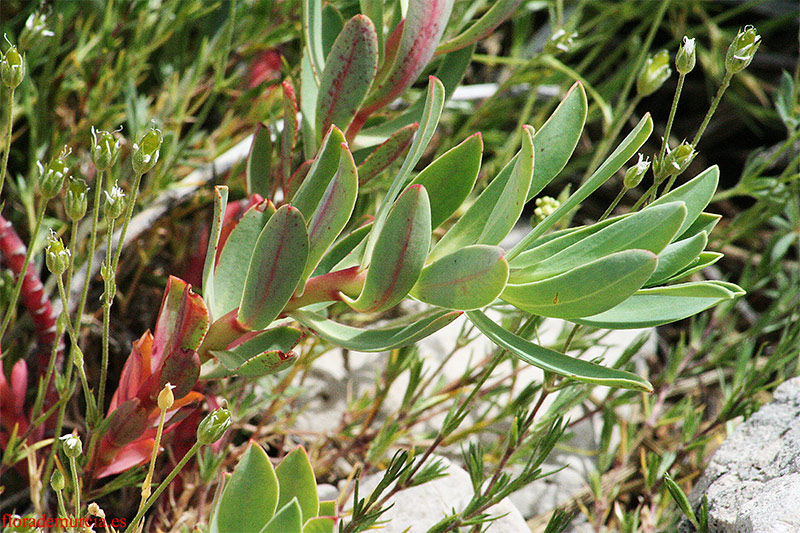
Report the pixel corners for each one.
[507,113,653,261]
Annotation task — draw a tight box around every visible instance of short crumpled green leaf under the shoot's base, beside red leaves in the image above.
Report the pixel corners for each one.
[203,326,303,379]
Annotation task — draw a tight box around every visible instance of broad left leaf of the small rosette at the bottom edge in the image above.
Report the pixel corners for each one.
[209,441,280,533]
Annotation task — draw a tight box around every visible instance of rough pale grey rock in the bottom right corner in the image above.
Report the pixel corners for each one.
[680,378,800,533]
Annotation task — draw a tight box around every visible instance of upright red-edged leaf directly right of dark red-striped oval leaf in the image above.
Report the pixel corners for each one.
[300,143,358,287]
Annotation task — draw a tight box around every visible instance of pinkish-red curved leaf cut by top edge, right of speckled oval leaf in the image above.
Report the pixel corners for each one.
[360,0,453,114]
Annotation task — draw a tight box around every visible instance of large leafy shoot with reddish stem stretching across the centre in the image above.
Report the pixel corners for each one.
[200,69,742,390]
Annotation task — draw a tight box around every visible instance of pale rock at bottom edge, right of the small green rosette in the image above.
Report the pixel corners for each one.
[350,457,530,533]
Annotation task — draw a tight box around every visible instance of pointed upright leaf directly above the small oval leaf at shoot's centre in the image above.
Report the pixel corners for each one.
[428,126,533,261]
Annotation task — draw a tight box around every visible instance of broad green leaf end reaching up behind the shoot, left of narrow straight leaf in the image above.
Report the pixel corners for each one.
[527,82,587,200]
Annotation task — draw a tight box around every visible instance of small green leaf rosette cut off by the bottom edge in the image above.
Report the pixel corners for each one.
[209,442,336,533]
